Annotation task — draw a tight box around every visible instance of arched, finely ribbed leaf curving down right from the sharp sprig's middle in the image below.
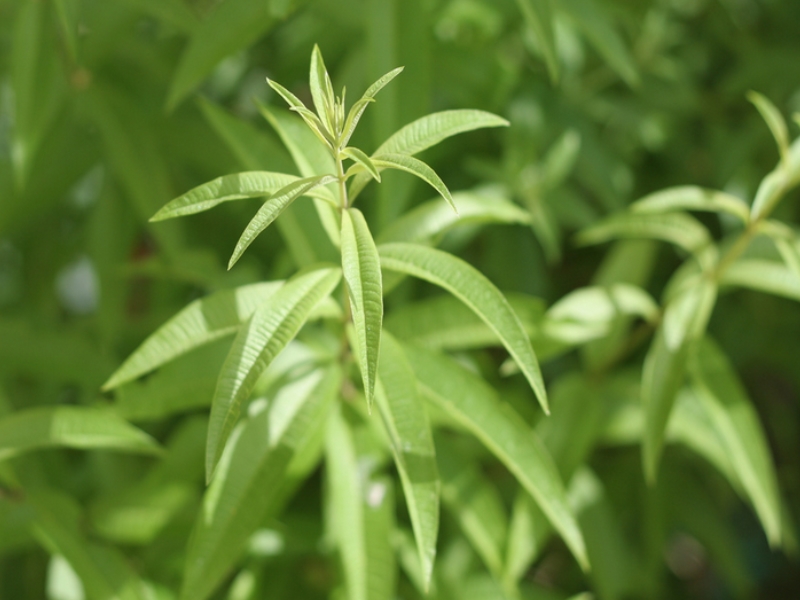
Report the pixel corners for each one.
[378,243,548,412]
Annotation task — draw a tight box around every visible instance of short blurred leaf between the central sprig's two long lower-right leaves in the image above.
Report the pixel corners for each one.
[439,444,508,579]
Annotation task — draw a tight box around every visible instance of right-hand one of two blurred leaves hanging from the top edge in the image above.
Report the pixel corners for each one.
[558,0,639,87]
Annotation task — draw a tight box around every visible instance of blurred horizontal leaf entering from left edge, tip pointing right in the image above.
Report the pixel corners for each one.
[0,406,160,460]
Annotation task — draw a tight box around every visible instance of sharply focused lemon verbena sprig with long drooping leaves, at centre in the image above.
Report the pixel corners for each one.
[100,47,588,600]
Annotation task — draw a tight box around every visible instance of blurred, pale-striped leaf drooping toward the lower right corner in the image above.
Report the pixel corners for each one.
[689,338,781,546]
